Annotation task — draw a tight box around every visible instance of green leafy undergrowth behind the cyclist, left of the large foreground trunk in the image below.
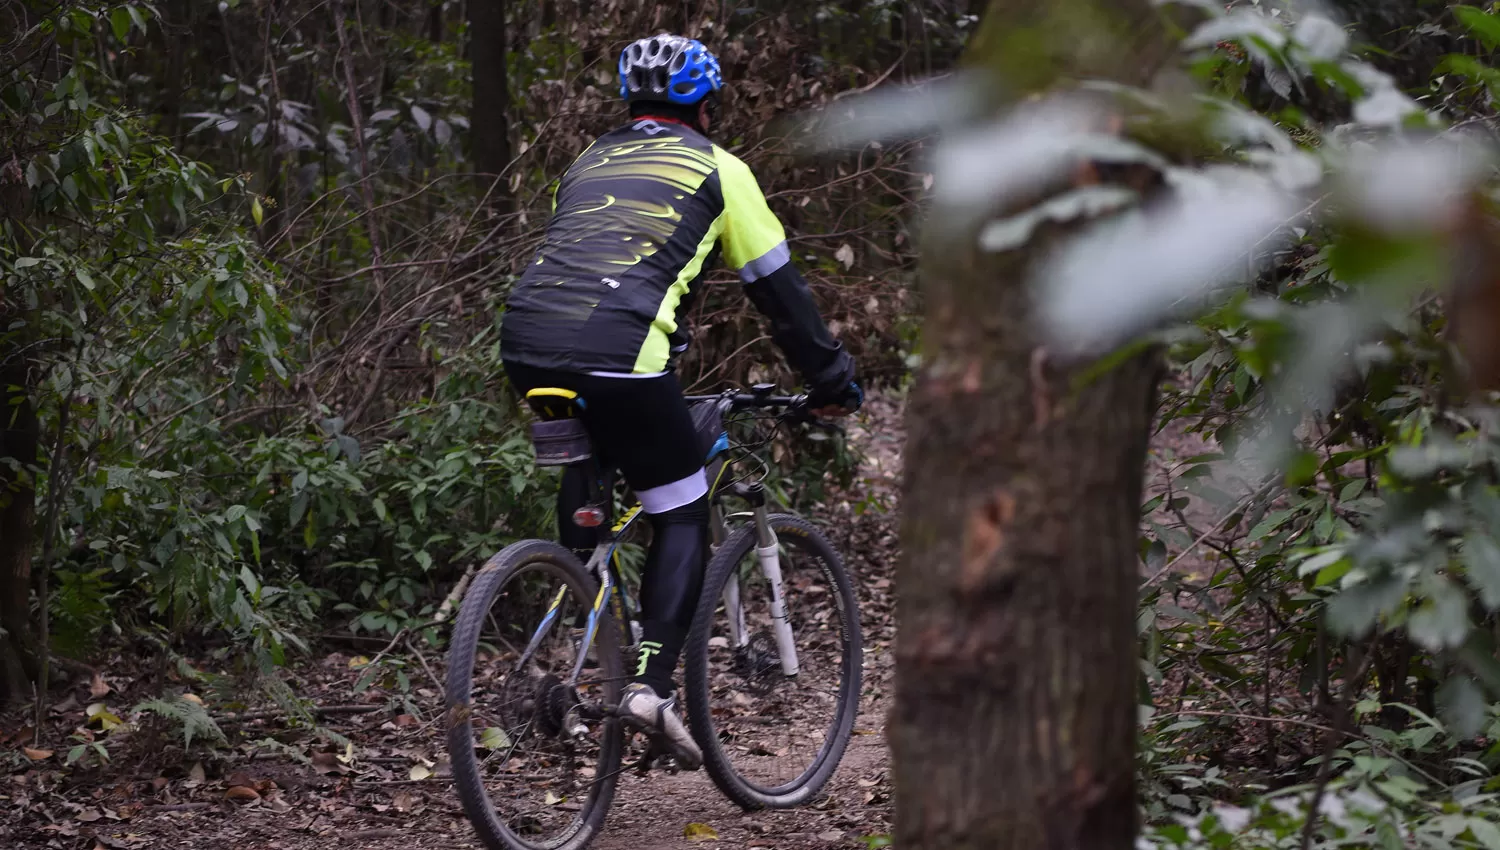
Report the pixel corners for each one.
[0,0,924,686]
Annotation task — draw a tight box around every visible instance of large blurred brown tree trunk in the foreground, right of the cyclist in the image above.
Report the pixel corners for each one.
[888,0,1170,850]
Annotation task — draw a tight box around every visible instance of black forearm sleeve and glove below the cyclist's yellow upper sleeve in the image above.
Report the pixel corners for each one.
[744,262,854,388]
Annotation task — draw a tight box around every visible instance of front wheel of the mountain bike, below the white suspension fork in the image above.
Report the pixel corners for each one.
[684,514,863,810]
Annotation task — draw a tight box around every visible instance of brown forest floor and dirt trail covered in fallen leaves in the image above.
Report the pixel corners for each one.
[0,386,1205,850]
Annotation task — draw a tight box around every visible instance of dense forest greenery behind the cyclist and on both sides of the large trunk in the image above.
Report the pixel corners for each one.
[11,0,1500,849]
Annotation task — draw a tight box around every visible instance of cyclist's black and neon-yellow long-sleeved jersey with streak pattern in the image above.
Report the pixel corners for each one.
[501,118,852,382]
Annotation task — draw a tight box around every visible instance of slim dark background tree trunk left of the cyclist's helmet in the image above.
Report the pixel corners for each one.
[468,0,510,213]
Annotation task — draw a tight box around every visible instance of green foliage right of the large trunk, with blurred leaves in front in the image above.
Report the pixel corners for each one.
[1098,0,1500,847]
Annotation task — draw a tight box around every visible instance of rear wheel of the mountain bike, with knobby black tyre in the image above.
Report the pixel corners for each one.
[447,540,624,850]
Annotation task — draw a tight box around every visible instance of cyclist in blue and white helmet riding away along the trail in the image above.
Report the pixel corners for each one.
[501,34,864,769]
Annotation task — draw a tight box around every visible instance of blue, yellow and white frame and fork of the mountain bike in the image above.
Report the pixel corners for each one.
[516,404,798,687]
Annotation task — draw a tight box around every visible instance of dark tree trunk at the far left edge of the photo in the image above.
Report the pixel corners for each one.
[0,346,39,705]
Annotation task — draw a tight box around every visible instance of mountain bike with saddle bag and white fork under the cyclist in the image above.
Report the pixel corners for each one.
[447,384,863,850]
